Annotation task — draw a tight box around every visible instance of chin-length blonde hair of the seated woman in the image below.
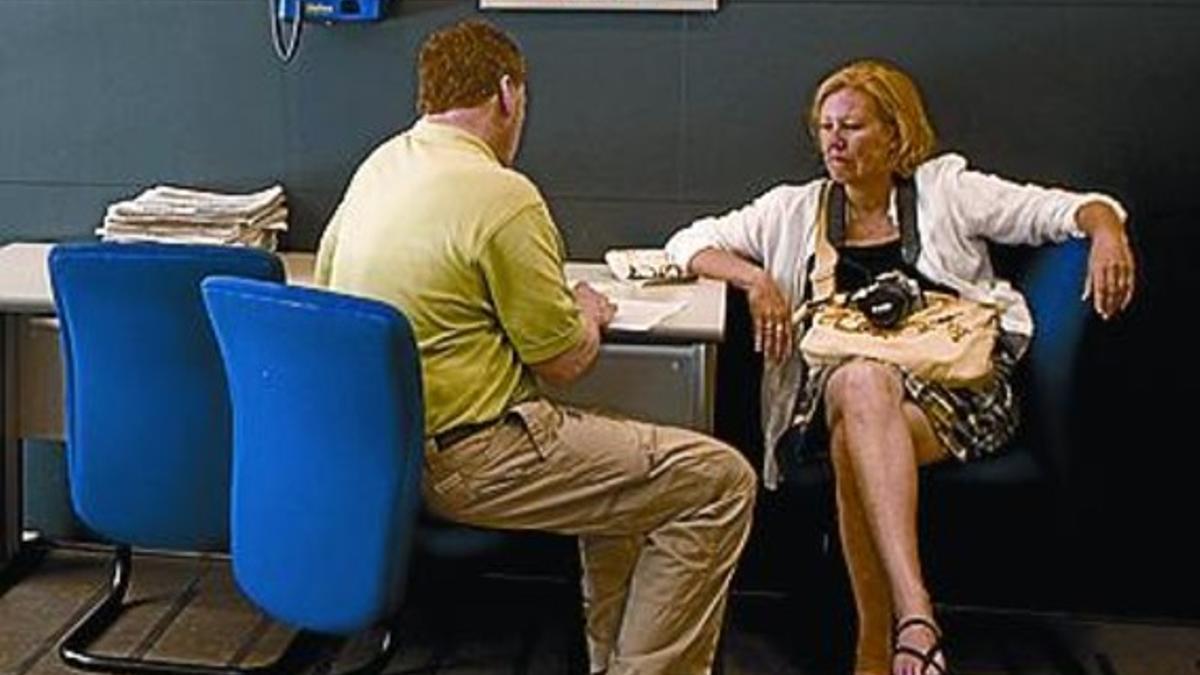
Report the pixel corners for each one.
[809,59,936,178]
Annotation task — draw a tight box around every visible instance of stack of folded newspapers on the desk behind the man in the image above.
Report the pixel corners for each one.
[96,185,288,251]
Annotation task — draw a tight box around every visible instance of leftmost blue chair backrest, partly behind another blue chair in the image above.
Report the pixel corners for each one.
[49,244,283,550]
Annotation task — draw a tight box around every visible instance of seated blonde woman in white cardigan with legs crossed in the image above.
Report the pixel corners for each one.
[667,60,1135,675]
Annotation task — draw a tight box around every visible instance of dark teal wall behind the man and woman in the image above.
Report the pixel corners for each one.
[0,0,1200,615]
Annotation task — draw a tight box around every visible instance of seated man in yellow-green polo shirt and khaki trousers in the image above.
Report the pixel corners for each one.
[317,20,756,675]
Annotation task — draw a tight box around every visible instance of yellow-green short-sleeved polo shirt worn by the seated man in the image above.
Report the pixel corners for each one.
[316,119,583,436]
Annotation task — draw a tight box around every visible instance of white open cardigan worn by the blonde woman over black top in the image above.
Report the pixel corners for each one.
[666,154,1126,489]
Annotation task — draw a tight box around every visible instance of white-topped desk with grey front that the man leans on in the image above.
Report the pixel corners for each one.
[0,239,725,568]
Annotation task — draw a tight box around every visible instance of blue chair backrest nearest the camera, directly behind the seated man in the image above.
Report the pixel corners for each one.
[204,279,425,634]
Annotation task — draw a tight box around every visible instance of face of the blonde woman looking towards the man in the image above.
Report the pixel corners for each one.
[818,86,895,185]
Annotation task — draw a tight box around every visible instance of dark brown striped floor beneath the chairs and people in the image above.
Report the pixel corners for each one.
[0,548,1200,675]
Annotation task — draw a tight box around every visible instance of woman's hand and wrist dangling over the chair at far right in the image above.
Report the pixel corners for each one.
[1075,201,1136,321]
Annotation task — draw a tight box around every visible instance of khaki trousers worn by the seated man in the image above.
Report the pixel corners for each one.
[425,400,756,675]
